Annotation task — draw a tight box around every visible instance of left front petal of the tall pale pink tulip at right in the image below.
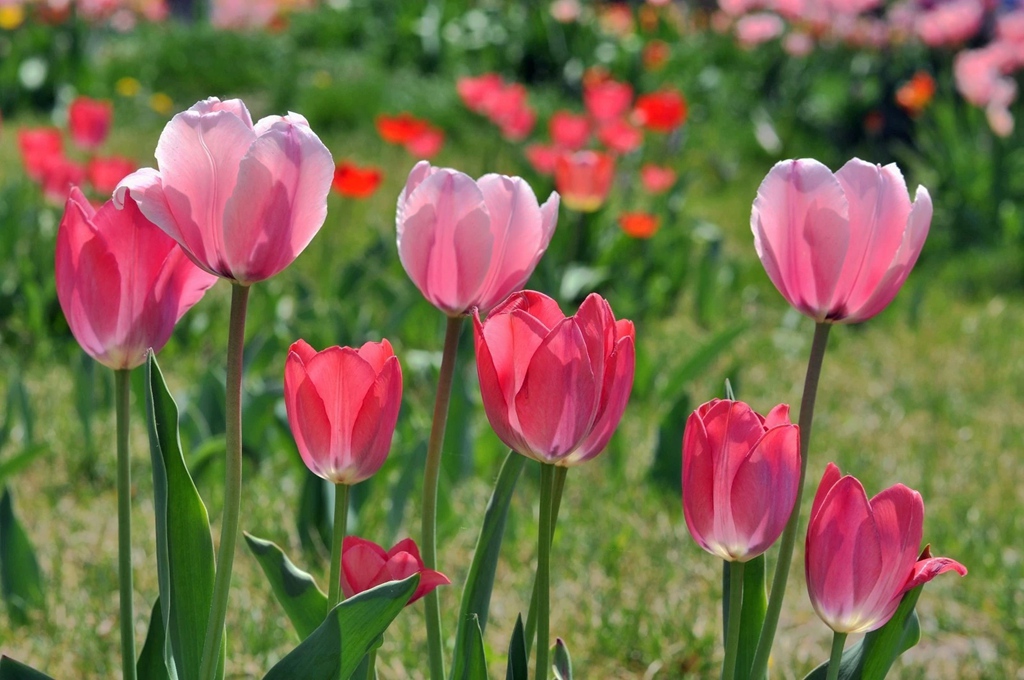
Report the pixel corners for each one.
[751,159,850,321]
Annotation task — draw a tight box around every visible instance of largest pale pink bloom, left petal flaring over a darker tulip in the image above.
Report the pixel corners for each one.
[114,97,334,286]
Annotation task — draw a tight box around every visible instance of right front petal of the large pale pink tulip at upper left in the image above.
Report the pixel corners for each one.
[221,119,334,284]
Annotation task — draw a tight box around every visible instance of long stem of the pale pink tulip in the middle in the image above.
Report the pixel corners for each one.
[420,316,462,680]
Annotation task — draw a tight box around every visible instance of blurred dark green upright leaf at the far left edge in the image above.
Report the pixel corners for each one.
[0,486,46,625]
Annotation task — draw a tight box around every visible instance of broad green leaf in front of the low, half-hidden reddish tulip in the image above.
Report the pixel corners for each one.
[263,573,420,680]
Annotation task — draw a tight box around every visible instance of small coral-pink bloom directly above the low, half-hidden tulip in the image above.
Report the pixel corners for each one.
[285,340,401,484]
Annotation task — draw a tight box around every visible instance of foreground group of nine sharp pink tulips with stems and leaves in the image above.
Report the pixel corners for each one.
[12,91,966,680]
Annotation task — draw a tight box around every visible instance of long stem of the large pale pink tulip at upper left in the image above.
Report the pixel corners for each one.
[200,284,249,680]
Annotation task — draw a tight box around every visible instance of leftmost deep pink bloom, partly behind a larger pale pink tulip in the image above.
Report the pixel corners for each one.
[54,187,216,370]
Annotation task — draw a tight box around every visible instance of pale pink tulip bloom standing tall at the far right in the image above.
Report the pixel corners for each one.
[751,159,932,324]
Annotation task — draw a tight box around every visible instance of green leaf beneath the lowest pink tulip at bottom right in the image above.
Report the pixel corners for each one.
[804,585,924,680]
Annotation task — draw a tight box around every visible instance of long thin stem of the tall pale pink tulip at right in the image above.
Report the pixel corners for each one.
[751,323,831,680]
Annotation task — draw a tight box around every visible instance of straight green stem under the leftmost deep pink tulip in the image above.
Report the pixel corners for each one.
[114,369,135,680]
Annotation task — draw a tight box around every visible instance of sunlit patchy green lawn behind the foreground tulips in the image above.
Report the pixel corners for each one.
[0,26,1024,679]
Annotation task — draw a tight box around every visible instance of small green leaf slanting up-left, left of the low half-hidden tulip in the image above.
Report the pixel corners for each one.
[245,534,328,640]
